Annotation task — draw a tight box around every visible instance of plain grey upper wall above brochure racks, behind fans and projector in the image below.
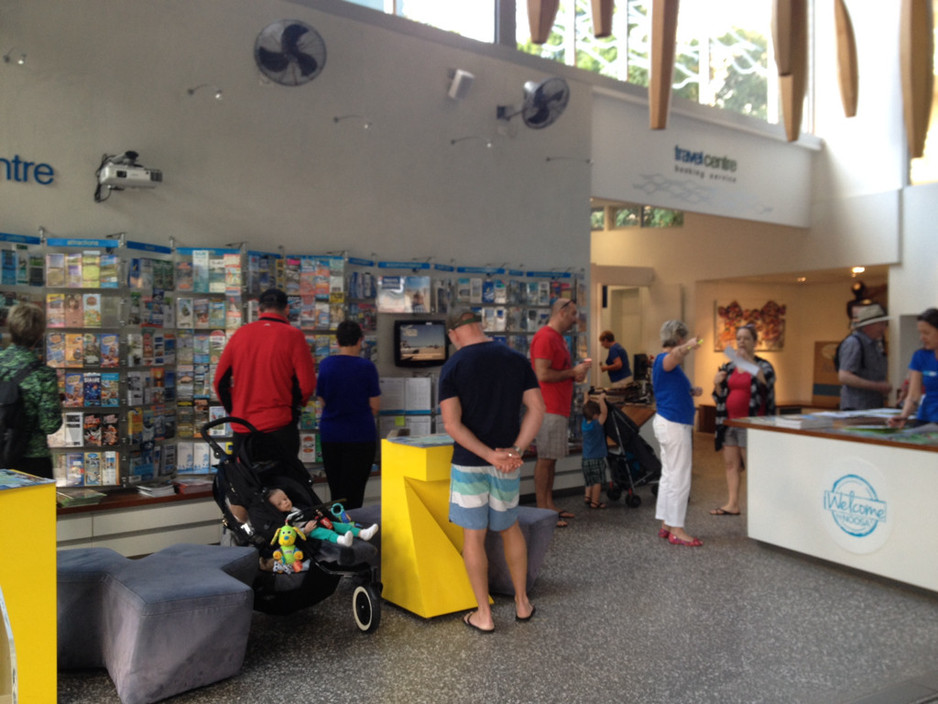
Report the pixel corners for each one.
[0,0,590,269]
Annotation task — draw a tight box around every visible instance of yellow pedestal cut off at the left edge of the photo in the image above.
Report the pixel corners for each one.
[0,469,57,702]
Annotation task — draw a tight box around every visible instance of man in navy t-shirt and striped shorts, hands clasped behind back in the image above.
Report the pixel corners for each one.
[439,310,545,633]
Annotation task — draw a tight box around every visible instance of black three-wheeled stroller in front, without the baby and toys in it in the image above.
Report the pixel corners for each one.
[202,417,381,633]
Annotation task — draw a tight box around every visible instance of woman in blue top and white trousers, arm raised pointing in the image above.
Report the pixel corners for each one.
[651,320,703,548]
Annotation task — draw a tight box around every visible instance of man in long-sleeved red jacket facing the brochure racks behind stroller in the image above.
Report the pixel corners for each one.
[215,288,316,460]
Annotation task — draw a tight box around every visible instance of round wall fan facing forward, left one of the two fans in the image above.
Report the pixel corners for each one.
[254,20,326,86]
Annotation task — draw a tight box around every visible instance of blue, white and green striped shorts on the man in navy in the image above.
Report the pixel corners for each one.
[449,464,521,531]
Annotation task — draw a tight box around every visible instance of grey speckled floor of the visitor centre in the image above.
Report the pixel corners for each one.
[59,434,938,704]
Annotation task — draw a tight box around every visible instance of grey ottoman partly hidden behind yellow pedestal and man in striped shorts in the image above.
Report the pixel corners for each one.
[349,505,557,596]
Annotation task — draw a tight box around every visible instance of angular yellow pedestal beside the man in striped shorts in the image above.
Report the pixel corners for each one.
[381,435,486,618]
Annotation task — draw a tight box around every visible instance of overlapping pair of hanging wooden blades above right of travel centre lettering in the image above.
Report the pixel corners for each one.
[772,0,808,142]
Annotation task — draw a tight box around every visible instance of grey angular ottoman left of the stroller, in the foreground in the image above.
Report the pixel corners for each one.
[58,544,257,704]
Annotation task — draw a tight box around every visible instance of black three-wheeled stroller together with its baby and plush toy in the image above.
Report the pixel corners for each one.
[202,417,381,633]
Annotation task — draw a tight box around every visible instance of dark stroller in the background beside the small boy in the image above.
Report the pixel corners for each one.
[603,404,661,508]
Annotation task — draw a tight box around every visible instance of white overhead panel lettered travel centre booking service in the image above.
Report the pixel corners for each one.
[591,95,817,227]
